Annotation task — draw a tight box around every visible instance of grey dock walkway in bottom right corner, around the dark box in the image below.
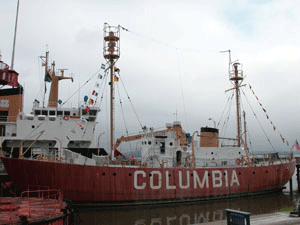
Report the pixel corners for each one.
[195,212,300,225]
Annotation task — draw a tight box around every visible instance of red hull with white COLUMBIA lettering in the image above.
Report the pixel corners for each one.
[1,158,296,204]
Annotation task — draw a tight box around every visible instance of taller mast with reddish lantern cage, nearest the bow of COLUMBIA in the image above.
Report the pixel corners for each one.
[103,23,120,159]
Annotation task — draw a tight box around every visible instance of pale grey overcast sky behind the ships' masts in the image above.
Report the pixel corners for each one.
[0,0,300,154]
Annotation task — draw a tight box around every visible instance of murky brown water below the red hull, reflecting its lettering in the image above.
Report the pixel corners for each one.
[70,193,295,225]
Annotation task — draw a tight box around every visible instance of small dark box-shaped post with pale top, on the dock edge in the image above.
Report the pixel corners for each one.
[225,209,251,225]
